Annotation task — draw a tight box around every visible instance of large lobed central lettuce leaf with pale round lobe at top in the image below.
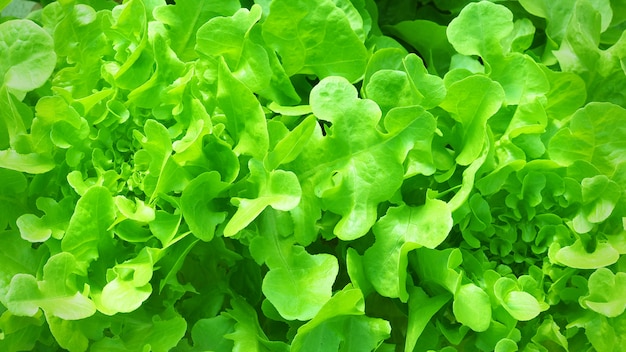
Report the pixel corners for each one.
[292,77,435,240]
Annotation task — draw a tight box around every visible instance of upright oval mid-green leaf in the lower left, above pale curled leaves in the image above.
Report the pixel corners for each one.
[61,186,115,262]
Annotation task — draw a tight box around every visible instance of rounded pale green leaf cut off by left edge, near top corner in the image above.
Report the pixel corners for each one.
[0,20,56,100]
